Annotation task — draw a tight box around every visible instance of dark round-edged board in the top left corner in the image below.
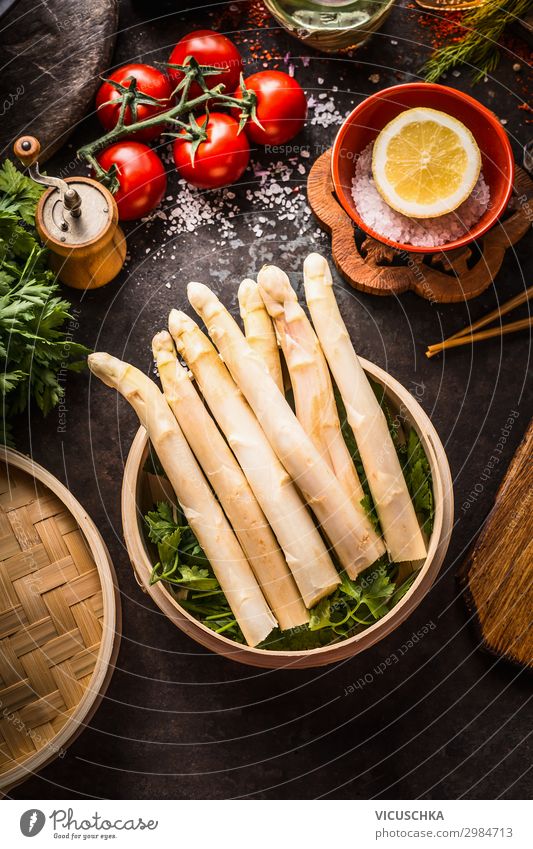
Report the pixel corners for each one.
[0,0,118,162]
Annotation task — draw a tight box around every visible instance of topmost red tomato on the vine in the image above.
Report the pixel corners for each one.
[168,29,242,98]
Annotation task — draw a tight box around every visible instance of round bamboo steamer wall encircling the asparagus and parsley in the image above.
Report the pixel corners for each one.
[122,357,453,669]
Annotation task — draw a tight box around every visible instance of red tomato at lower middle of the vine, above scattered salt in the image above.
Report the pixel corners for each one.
[174,112,250,189]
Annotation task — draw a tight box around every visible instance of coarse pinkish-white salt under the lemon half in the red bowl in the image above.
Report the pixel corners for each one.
[352,142,490,248]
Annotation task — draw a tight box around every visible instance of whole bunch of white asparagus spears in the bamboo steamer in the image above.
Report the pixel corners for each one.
[89,254,426,646]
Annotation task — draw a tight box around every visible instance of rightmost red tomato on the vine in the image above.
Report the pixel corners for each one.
[232,71,307,144]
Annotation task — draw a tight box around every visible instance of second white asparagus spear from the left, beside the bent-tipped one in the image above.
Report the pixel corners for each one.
[152,330,309,630]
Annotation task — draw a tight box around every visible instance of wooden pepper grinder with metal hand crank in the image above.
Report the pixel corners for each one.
[13,136,126,289]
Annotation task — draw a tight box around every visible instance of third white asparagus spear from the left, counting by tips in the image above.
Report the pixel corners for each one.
[169,310,340,607]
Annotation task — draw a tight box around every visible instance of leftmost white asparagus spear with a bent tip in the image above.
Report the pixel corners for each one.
[88,353,277,646]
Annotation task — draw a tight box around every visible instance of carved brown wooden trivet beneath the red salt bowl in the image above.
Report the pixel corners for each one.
[307,150,533,304]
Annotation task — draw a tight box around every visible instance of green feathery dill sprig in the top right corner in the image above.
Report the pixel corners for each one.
[422,0,533,83]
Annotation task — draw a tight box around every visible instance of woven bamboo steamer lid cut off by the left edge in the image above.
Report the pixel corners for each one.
[0,447,120,792]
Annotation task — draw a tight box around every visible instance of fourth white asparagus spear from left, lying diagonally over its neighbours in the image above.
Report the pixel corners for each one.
[187,283,381,578]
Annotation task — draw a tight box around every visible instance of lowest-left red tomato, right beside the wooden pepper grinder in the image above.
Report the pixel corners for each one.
[96,141,167,221]
